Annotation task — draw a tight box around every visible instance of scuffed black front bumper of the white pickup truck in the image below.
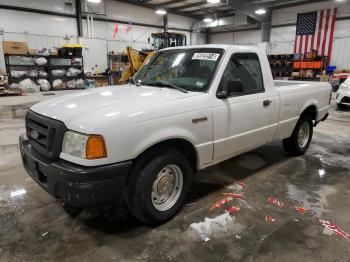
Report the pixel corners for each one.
[19,134,132,208]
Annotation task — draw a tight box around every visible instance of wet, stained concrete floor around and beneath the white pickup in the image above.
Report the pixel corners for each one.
[0,91,350,261]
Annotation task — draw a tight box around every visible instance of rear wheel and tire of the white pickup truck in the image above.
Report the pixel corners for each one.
[283,114,313,156]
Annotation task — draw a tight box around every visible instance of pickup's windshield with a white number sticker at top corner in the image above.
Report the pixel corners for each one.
[134,48,224,92]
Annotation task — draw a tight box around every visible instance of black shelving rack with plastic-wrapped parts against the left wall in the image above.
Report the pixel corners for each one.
[4,54,85,90]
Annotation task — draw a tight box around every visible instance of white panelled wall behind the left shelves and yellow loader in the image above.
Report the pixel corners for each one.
[0,0,205,71]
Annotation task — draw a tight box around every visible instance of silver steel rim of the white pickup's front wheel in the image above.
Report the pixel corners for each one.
[151,164,183,211]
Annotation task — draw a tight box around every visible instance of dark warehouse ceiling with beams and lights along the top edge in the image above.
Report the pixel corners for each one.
[119,0,325,20]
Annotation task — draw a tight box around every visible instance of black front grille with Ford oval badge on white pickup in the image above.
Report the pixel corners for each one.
[26,111,67,159]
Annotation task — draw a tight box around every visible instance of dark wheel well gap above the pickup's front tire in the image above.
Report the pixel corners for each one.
[139,138,197,172]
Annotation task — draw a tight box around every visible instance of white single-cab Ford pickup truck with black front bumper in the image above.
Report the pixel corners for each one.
[20,45,331,224]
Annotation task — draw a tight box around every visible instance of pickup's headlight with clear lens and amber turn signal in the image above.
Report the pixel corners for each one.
[62,131,107,159]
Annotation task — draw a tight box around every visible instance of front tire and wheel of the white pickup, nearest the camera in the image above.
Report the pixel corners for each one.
[126,147,193,226]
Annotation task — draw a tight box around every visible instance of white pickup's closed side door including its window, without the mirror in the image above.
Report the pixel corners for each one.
[213,53,275,163]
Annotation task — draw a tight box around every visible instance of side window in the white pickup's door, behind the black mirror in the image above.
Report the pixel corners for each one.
[219,53,264,96]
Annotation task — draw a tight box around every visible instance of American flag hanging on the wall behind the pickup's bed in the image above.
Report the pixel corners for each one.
[294,8,337,59]
